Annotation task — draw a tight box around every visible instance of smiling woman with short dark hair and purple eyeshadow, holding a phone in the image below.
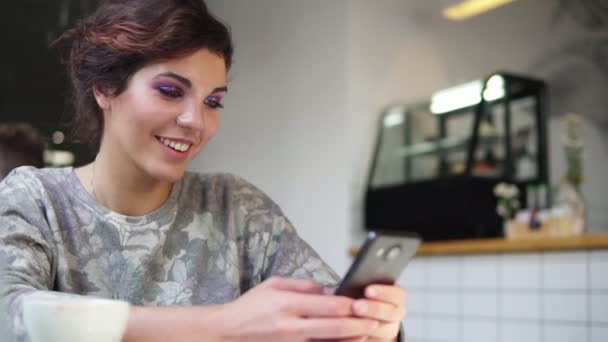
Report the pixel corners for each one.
[0,0,405,341]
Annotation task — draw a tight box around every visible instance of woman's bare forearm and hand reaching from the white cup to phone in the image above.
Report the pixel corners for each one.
[123,278,378,342]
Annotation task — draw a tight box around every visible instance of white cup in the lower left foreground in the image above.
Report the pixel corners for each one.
[23,295,129,342]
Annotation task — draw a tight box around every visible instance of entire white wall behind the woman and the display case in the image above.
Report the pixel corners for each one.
[193,0,608,272]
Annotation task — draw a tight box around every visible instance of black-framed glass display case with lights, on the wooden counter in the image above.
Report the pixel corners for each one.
[366,73,548,240]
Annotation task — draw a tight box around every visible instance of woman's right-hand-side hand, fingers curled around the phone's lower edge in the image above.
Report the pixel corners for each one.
[346,285,407,341]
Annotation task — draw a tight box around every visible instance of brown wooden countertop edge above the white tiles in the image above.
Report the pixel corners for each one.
[350,234,608,256]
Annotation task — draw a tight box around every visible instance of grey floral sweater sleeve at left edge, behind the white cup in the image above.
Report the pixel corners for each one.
[0,173,81,341]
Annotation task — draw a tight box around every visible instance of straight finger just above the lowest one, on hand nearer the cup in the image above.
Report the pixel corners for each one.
[285,293,355,318]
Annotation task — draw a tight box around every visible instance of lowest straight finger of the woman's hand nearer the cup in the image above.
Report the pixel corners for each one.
[297,318,379,339]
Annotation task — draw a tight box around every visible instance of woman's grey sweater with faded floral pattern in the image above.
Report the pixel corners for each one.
[0,167,338,340]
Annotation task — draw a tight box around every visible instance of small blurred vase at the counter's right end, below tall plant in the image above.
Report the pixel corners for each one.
[553,182,587,235]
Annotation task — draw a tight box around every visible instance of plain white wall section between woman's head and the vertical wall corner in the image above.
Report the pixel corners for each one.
[197,0,353,272]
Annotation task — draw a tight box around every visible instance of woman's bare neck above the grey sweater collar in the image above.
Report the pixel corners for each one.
[77,149,172,216]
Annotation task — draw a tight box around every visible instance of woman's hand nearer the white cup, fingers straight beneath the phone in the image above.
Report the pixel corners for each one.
[220,278,380,342]
